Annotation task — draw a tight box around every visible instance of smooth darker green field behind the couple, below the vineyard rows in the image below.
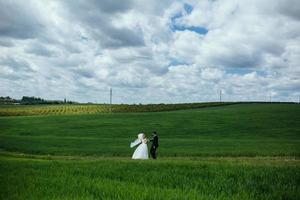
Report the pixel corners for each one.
[0,104,300,157]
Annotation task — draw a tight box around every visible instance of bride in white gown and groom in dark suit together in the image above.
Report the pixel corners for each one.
[130,131,158,159]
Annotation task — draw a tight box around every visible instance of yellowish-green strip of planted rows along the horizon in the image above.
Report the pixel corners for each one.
[0,102,236,116]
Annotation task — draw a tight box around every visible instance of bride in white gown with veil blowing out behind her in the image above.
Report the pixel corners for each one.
[130,133,149,159]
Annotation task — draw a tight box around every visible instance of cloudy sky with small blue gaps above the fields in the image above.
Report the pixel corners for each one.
[0,0,300,104]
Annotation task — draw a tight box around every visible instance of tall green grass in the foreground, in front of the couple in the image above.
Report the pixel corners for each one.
[0,155,300,200]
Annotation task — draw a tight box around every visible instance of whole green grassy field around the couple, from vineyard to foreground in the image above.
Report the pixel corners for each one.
[0,104,300,199]
